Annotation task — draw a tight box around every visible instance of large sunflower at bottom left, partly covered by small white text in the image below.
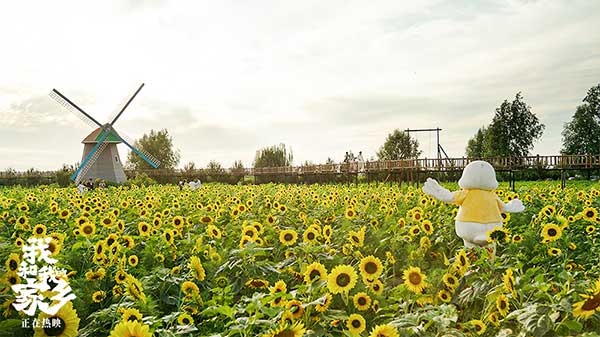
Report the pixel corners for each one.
[33,302,79,337]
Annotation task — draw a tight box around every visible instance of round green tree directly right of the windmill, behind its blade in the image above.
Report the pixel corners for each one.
[127,129,180,170]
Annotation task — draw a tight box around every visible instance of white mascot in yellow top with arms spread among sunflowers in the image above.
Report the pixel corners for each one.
[423,160,525,248]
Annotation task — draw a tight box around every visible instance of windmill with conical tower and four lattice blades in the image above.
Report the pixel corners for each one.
[50,83,160,184]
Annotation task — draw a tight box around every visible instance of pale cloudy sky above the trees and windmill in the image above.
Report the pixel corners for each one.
[0,0,600,171]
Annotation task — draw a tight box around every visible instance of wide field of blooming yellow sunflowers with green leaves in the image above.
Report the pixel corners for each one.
[0,182,600,337]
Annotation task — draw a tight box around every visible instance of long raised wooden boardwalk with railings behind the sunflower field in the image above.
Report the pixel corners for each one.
[0,155,600,187]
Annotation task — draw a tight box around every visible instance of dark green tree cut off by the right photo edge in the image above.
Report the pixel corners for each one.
[561,84,600,154]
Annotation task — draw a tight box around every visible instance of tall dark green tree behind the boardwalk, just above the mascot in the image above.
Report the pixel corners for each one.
[487,92,545,157]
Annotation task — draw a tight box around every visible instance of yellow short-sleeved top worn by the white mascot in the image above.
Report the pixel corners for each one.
[452,189,504,223]
